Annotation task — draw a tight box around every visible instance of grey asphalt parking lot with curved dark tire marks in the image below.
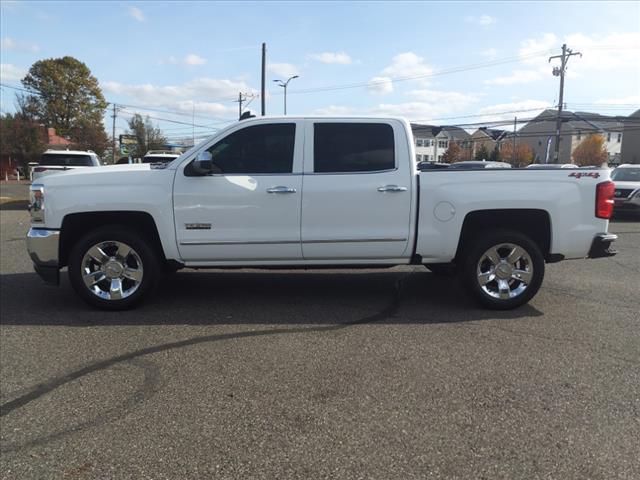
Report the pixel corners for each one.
[0,202,640,479]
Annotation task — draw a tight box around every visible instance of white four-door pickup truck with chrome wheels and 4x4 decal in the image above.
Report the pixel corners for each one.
[27,117,616,310]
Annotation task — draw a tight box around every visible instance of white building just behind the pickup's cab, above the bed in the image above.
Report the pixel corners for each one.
[411,124,471,162]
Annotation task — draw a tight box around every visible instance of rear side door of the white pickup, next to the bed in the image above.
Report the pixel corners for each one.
[301,121,412,260]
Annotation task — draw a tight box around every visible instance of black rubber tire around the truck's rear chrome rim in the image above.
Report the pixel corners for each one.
[462,230,545,310]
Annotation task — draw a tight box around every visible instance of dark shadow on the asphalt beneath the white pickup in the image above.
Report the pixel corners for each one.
[0,269,543,326]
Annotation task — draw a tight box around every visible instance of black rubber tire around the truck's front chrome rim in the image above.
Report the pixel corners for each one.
[69,225,161,310]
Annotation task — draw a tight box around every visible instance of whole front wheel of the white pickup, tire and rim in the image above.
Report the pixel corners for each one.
[69,226,160,310]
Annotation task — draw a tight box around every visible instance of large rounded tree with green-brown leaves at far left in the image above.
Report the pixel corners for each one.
[19,56,108,154]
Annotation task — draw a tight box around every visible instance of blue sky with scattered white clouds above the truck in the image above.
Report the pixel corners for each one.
[0,0,640,141]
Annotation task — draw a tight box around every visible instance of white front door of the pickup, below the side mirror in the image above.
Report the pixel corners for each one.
[174,121,304,262]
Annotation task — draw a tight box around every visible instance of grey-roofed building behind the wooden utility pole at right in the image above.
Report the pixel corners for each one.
[517,109,624,164]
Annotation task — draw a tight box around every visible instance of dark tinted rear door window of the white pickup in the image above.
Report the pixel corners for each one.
[313,122,396,173]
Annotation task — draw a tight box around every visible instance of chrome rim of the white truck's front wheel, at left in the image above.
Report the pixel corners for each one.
[80,240,144,300]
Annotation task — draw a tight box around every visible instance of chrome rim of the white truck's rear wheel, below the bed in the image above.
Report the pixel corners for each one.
[477,243,533,300]
